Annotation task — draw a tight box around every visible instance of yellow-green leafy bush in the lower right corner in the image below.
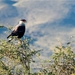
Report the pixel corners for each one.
[41,45,75,75]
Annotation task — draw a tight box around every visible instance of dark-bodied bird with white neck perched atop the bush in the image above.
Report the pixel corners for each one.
[7,19,27,41]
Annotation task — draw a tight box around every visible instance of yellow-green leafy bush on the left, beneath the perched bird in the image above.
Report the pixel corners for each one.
[0,39,40,75]
